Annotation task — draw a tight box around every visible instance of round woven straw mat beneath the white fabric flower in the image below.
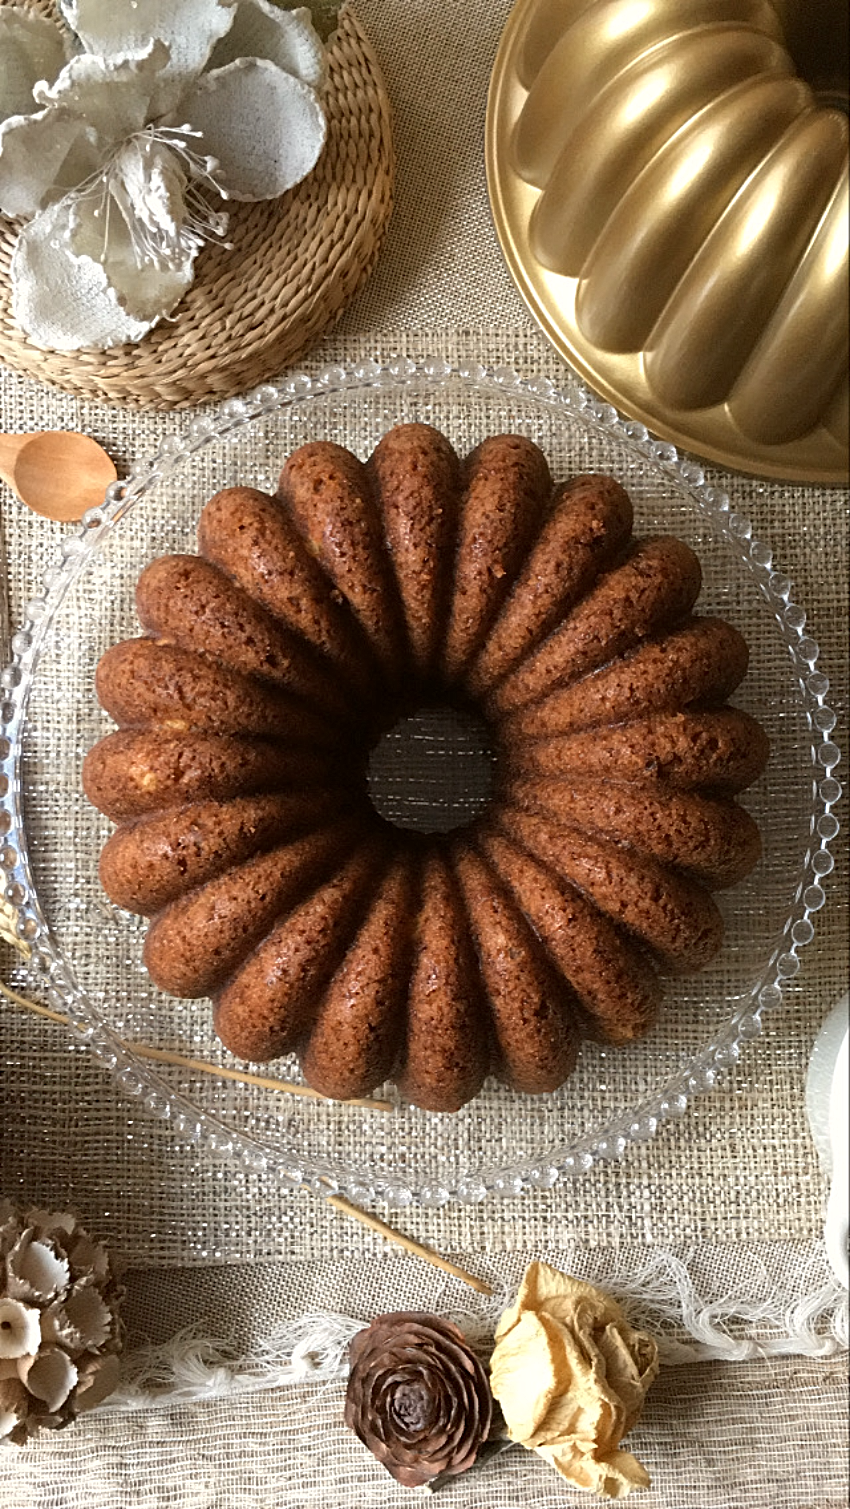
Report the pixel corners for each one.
[0,0,394,409]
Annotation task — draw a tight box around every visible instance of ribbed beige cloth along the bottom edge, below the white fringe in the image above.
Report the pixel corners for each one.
[0,1358,847,1509]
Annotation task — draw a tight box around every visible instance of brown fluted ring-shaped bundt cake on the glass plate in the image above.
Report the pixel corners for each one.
[83,424,767,1111]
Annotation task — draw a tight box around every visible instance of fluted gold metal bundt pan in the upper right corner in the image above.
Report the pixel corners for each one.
[486,0,848,483]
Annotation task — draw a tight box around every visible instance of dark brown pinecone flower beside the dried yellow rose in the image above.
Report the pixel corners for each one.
[346,1311,492,1488]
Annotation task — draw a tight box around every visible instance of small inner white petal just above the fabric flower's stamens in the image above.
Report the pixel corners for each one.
[36,41,169,145]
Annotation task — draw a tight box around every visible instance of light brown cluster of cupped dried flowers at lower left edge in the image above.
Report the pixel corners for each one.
[0,1200,124,1446]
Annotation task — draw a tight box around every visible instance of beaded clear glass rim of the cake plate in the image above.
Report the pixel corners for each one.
[0,358,841,1206]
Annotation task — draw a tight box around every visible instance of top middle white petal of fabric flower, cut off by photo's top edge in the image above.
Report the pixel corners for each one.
[62,0,234,94]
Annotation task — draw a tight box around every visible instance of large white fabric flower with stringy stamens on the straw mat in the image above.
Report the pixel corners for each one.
[0,0,326,350]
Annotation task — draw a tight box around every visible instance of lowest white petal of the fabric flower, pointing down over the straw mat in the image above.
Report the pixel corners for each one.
[11,195,195,352]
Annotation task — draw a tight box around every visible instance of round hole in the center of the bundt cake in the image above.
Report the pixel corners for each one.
[368,706,492,833]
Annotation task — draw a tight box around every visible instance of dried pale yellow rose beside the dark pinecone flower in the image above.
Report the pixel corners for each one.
[491,1263,658,1498]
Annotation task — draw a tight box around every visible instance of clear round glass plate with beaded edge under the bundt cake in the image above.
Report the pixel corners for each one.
[0,361,841,1204]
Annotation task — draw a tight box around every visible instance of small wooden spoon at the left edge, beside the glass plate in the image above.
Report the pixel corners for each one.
[0,430,118,524]
